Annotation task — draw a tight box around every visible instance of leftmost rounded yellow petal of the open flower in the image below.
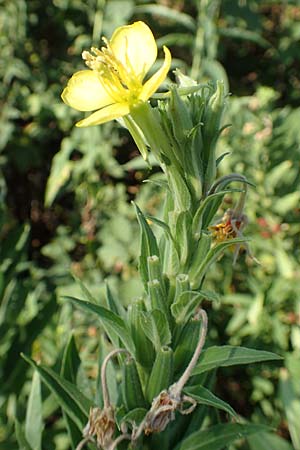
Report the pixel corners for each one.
[61,70,114,111]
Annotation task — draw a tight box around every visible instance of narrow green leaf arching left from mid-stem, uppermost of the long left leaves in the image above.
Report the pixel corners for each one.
[64,297,135,355]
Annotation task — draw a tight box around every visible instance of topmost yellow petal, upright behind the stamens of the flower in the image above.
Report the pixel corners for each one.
[110,21,157,81]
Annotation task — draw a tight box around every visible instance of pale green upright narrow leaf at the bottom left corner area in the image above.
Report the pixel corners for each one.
[25,371,44,450]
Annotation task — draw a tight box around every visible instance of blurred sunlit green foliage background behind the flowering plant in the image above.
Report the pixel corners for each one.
[0,0,300,450]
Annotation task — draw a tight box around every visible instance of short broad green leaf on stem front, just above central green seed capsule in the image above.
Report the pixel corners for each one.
[141,309,172,351]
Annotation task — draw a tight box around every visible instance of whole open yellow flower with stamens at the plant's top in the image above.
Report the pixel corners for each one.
[62,22,171,127]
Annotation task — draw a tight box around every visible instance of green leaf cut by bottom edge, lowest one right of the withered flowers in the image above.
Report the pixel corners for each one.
[176,423,265,450]
